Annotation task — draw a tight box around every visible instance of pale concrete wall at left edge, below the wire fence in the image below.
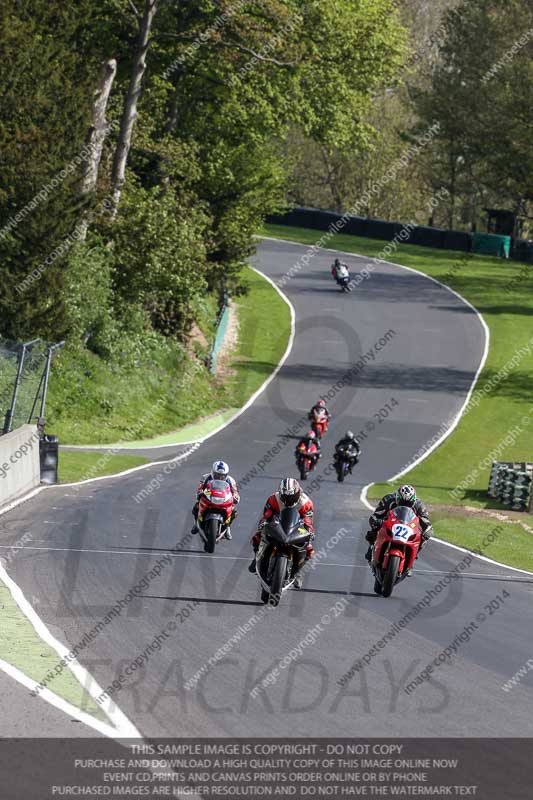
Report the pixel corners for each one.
[0,425,41,508]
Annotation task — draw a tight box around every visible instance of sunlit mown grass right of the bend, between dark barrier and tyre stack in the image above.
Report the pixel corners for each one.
[264,225,533,563]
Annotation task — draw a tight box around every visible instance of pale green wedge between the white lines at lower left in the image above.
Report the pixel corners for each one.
[0,581,110,724]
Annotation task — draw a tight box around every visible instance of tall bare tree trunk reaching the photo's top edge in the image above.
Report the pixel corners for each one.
[111,0,159,218]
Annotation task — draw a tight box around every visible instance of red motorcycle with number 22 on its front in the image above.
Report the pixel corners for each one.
[370,506,422,597]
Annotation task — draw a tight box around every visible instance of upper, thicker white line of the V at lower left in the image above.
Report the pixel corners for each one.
[0,564,142,739]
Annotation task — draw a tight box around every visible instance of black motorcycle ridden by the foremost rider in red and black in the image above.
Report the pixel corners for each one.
[256,508,309,606]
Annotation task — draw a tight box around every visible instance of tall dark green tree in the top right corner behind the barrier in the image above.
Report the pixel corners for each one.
[415,0,533,222]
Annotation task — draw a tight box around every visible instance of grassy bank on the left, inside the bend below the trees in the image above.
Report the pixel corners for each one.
[47,267,290,446]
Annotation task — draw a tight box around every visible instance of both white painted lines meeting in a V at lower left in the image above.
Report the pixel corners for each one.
[0,564,142,739]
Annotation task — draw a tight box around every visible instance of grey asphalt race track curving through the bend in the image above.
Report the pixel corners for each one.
[2,241,533,737]
